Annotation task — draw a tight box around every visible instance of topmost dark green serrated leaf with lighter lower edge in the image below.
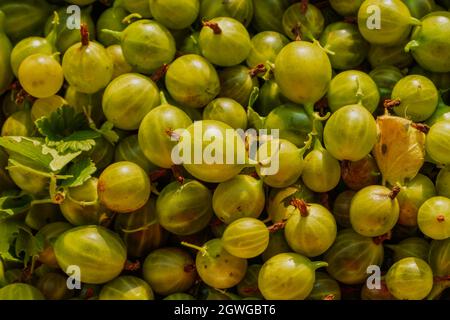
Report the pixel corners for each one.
[36,106,101,154]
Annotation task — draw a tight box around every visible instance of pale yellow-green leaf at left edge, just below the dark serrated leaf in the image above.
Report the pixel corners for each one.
[0,137,81,172]
